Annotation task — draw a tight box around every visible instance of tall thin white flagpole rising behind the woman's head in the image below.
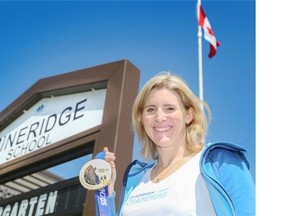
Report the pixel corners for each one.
[197,0,204,101]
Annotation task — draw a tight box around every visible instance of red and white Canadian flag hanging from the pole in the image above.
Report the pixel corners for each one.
[197,4,220,58]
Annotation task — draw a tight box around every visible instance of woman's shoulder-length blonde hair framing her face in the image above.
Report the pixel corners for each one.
[132,72,211,160]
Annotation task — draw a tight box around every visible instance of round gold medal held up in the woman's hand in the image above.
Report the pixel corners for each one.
[79,159,112,190]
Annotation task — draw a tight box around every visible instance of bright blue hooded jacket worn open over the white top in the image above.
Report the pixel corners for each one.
[105,142,256,216]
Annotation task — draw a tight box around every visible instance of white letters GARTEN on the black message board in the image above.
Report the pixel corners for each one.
[0,191,58,216]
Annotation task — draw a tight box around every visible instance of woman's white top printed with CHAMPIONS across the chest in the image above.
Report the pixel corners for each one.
[121,153,216,216]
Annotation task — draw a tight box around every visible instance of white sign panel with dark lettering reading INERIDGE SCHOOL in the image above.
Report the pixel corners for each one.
[0,89,106,164]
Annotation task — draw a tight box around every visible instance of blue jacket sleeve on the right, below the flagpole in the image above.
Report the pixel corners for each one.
[208,145,255,216]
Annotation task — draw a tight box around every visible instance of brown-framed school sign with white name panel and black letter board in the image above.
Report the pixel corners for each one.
[0,60,140,216]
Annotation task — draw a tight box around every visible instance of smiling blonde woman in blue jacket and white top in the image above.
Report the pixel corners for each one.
[104,72,255,216]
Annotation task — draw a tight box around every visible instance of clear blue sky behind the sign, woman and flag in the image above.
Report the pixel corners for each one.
[0,0,256,182]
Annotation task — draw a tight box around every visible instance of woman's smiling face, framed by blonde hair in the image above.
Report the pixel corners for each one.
[141,88,193,148]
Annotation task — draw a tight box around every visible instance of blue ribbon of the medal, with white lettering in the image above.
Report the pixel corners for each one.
[95,152,112,216]
